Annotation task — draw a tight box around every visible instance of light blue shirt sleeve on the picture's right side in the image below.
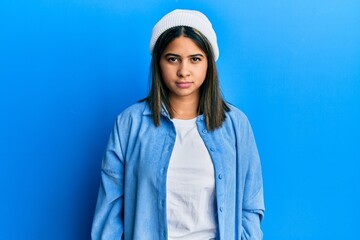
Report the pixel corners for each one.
[240,114,265,240]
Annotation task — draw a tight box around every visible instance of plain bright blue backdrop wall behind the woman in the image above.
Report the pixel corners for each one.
[0,0,360,240]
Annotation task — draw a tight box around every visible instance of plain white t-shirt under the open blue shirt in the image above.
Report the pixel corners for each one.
[166,118,217,240]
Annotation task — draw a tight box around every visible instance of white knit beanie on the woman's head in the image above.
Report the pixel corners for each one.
[150,9,219,61]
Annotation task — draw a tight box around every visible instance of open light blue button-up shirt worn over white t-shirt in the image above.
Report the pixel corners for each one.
[91,102,264,240]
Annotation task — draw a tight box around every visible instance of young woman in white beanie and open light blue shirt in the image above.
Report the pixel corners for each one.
[92,10,264,240]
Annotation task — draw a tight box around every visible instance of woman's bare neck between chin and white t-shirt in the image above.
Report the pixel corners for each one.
[170,94,199,119]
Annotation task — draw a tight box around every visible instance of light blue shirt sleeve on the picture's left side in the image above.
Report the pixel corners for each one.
[91,119,124,240]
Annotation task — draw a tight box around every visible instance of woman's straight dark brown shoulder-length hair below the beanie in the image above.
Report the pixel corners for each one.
[146,26,230,131]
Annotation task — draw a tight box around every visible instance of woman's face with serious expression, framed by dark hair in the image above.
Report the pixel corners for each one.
[160,36,208,100]
